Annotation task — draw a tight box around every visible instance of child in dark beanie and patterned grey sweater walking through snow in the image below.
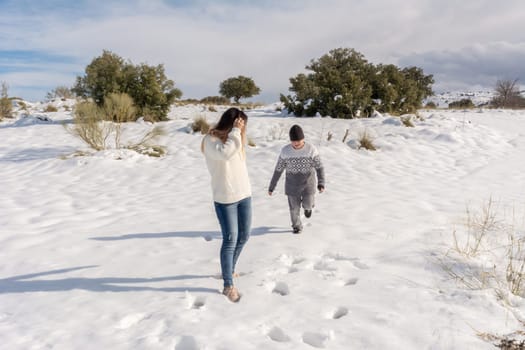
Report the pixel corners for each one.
[268,125,324,233]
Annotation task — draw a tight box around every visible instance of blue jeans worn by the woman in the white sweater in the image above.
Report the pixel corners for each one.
[214,197,252,287]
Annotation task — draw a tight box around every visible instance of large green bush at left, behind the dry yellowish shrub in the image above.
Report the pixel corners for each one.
[72,50,182,121]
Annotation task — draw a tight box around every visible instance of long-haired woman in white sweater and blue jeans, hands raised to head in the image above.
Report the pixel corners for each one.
[201,108,252,302]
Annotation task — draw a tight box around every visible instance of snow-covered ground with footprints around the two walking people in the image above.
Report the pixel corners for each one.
[0,103,525,350]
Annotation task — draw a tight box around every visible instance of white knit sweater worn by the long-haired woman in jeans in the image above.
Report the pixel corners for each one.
[203,128,252,204]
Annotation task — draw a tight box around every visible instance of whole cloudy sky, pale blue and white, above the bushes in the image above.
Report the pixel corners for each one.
[0,0,525,102]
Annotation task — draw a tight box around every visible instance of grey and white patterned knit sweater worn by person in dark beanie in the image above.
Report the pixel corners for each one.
[268,142,324,196]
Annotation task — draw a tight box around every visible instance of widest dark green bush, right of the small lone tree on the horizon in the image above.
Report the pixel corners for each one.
[280,48,434,118]
